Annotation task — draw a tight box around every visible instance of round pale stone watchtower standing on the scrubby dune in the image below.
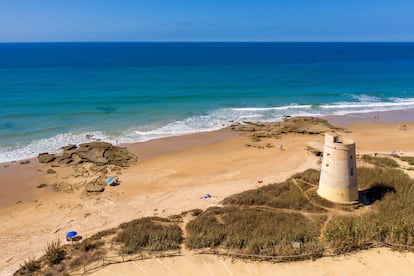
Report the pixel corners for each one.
[318,132,358,203]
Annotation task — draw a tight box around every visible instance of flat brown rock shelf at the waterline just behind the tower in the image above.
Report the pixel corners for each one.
[230,117,343,141]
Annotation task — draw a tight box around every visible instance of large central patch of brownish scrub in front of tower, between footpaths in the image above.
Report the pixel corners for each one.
[186,206,323,255]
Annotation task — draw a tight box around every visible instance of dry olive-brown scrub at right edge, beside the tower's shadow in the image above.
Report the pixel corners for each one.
[324,165,414,253]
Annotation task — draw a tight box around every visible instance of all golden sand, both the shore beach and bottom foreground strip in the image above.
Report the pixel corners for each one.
[0,111,414,275]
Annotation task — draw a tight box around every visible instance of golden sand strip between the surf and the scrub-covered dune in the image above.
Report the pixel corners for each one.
[0,110,414,273]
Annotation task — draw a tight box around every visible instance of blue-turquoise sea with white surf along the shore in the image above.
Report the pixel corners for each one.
[0,43,414,162]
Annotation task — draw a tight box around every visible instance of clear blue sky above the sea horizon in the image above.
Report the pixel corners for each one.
[0,0,414,42]
